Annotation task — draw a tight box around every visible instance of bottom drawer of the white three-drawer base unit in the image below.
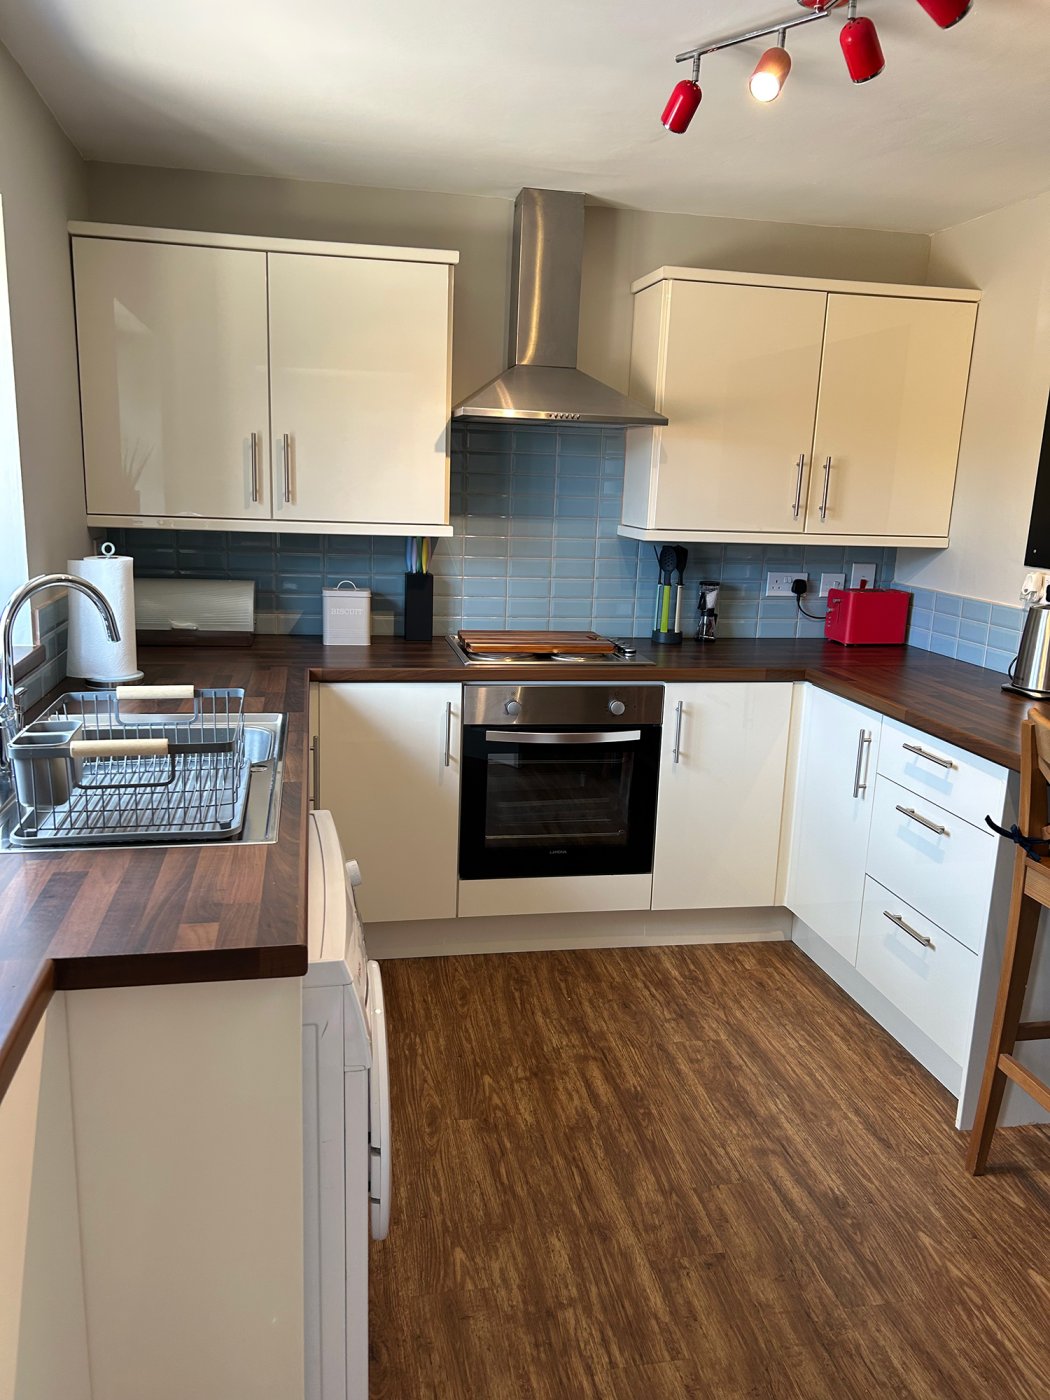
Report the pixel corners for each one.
[857,876,977,1064]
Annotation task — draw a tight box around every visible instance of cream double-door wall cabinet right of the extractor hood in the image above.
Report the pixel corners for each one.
[620,267,980,546]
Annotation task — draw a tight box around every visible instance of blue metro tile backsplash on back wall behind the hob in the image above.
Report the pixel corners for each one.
[96,426,896,637]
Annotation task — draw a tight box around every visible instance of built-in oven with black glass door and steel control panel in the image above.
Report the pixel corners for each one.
[459,685,664,879]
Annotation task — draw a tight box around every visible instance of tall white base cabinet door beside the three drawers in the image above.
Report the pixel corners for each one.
[787,686,882,963]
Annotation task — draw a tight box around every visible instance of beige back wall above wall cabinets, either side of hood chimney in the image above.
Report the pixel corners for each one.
[88,164,930,399]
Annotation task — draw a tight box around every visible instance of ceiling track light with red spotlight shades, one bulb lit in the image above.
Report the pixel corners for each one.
[661,0,973,136]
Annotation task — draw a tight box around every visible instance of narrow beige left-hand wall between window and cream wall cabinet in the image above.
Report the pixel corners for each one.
[0,46,87,573]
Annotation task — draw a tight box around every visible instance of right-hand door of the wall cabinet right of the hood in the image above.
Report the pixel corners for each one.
[805,293,977,536]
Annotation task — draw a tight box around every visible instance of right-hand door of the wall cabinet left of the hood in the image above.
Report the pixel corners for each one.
[269,253,451,528]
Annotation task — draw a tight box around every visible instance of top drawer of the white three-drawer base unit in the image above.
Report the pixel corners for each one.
[879,720,1007,826]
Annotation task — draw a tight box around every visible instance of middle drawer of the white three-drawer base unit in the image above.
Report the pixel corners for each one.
[868,777,998,952]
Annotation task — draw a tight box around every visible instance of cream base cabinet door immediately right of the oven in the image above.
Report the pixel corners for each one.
[652,682,792,909]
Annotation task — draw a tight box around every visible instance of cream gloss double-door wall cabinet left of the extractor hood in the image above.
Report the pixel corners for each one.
[70,224,459,535]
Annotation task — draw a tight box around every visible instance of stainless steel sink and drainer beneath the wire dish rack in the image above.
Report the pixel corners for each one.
[0,714,287,854]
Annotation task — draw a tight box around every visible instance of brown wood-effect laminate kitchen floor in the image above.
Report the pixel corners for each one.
[371,944,1050,1400]
